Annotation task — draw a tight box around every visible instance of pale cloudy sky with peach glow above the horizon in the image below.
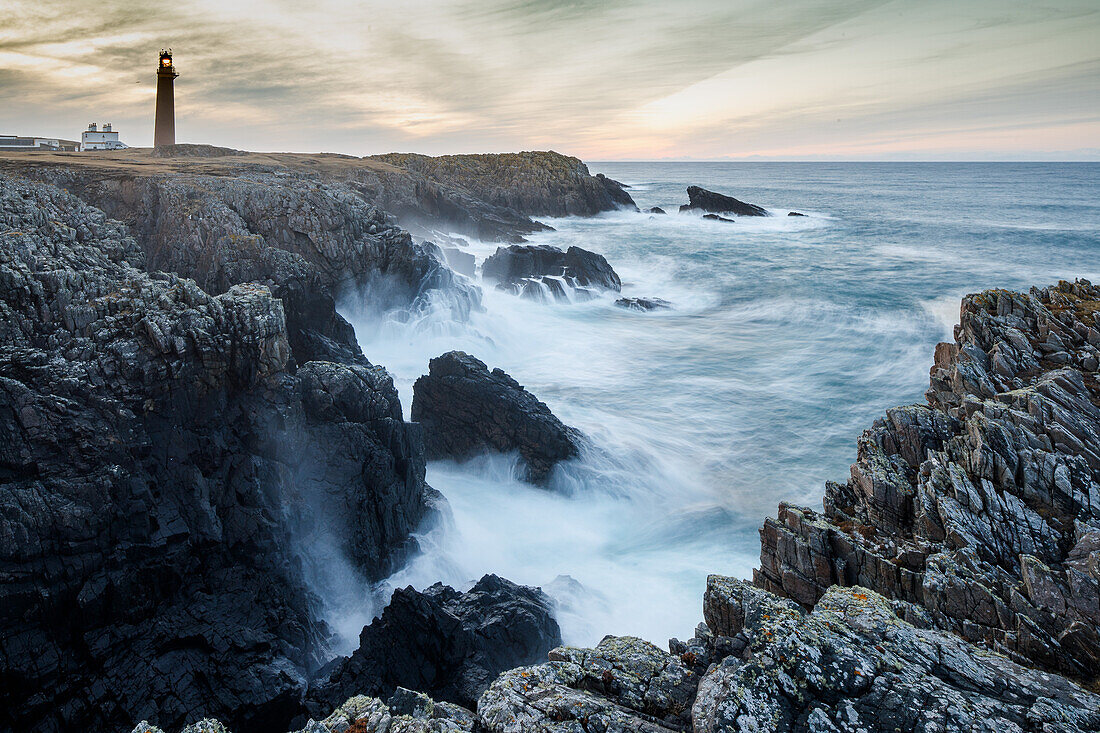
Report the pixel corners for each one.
[0,0,1100,161]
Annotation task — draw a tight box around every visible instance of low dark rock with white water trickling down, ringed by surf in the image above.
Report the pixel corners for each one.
[482,244,623,292]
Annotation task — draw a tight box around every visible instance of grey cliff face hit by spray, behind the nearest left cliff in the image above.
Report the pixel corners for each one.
[8,167,480,363]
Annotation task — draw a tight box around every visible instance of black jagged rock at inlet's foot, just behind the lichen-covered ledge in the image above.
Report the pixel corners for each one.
[309,576,561,716]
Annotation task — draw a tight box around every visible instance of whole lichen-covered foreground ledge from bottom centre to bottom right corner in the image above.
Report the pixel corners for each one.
[477,576,1100,733]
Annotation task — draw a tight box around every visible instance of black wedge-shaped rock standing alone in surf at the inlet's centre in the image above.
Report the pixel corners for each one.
[413,351,581,483]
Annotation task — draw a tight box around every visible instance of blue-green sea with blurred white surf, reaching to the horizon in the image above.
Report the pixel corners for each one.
[338,163,1100,645]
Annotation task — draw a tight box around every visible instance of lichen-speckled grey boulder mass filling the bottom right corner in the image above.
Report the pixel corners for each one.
[692,576,1100,733]
